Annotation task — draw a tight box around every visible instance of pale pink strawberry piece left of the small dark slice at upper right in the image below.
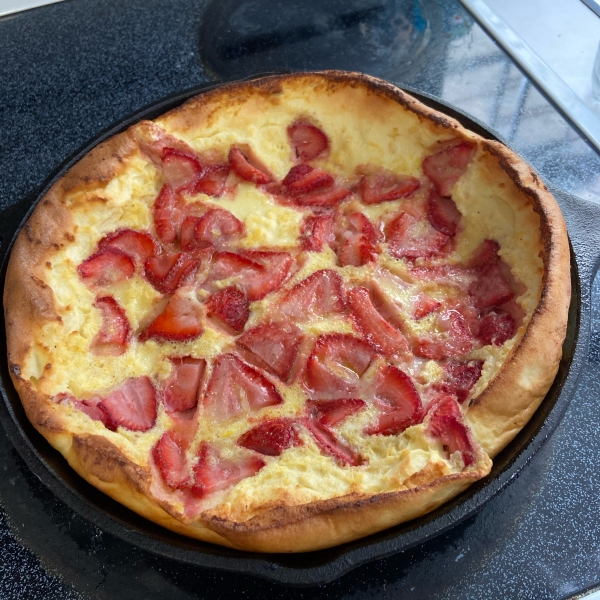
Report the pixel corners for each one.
[385,213,451,259]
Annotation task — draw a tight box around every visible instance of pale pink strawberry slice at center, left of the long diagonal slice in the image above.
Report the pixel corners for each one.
[279,269,344,321]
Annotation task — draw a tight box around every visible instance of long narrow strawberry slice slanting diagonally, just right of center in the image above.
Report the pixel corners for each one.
[347,287,408,356]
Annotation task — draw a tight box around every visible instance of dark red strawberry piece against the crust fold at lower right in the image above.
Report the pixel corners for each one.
[426,396,475,467]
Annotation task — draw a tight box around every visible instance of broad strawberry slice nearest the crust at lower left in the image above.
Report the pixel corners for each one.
[98,377,156,431]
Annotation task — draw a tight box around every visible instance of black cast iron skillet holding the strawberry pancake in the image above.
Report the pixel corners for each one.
[0,75,600,586]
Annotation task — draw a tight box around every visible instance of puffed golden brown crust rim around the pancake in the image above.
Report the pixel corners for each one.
[4,71,570,552]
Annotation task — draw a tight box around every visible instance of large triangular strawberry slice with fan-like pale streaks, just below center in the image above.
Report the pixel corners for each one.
[202,354,283,421]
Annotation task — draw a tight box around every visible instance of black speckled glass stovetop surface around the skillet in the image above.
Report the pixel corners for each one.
[0,0,600,600]
